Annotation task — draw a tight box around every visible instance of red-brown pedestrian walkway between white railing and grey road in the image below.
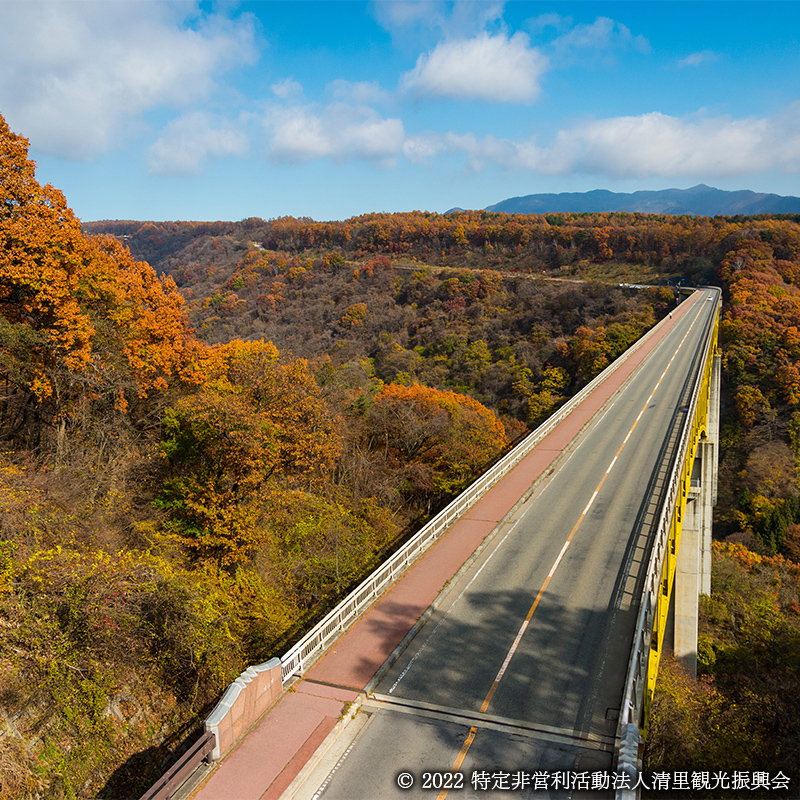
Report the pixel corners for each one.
[191,294,699,800]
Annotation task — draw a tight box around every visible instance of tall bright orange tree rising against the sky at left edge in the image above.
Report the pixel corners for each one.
[0,117,190,460]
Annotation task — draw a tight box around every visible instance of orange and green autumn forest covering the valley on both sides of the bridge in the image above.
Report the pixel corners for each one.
[0,117,800,799]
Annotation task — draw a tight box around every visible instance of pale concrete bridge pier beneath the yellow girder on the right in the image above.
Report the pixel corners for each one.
[667,355,721,676]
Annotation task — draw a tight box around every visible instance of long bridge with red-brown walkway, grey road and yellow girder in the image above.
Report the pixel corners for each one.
[145,289,720,800]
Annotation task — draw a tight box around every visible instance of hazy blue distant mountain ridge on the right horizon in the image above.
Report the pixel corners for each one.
[486,183,800,217]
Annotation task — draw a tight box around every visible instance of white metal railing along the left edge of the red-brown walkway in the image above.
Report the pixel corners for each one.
[281,310,669,683]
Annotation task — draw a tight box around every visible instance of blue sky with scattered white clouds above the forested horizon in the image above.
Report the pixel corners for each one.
[0,0,800,220]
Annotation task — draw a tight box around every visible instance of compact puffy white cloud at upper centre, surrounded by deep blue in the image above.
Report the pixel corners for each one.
[402,33,547,103]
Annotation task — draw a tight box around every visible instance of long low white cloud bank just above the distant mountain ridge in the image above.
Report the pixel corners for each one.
[404,102,800,179]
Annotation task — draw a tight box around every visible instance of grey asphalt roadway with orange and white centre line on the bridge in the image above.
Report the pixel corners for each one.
[297,291,716,800]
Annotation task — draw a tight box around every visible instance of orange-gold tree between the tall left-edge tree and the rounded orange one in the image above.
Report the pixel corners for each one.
[158,340,341,567]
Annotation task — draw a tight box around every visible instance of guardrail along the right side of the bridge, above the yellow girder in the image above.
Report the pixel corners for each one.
[616,296,721,800]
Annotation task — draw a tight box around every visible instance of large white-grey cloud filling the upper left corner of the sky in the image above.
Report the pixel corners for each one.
[0,0,256,159]
